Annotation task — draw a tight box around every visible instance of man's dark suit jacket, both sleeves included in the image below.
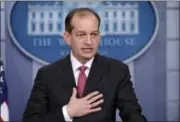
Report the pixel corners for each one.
[23,54,146,122]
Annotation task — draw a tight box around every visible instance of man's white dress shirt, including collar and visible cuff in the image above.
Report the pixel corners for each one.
[62,52,94,121]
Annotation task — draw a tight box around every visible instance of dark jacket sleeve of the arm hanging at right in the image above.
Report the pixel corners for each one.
[116,65,147,122]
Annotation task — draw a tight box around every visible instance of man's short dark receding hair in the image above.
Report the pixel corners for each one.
[65,7,101,33]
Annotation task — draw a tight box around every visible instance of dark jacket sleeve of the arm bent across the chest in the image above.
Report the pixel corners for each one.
[22,70,65,122]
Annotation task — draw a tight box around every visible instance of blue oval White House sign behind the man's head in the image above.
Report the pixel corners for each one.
[8,1,159,64]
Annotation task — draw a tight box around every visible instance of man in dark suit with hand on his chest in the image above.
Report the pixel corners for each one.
[23,8,147,122]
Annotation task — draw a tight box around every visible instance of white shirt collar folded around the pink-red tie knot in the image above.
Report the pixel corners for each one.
[70,51,94,72]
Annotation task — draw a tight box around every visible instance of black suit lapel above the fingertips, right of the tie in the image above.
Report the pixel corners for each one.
[83,54,108,96]
